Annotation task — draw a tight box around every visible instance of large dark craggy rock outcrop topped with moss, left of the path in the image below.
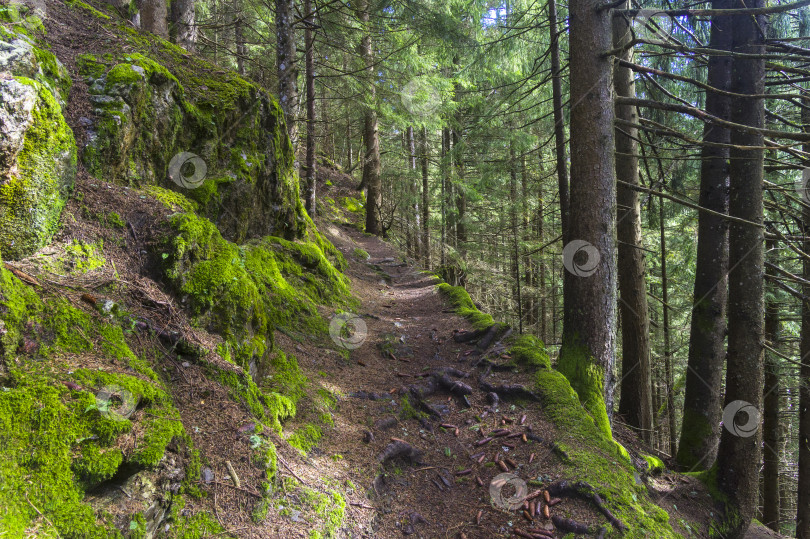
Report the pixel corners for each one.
[80,47,306,243]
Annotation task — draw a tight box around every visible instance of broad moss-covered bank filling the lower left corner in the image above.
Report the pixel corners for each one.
[0,268,187,538]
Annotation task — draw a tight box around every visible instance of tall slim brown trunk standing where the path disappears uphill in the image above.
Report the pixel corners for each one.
[356,0,382,235]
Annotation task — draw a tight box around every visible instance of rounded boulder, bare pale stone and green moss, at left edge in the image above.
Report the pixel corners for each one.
[0,76,76,259]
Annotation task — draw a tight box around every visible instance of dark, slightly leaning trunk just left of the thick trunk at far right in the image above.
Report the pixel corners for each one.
[677,0,736,471]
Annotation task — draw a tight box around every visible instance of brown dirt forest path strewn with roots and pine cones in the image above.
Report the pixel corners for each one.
[312,221,584,538]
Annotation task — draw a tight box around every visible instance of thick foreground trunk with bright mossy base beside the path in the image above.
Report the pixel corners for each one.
[558,0,616,438]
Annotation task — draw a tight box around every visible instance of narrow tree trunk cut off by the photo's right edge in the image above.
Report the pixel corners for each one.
[796,94,810,539]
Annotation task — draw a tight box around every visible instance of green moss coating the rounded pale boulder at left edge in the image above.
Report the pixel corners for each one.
[0,77,76,258]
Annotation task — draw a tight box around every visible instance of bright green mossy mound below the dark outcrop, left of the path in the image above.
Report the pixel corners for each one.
[159,213,351,380]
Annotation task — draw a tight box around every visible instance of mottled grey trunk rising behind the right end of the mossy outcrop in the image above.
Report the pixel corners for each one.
[276,0,298,147]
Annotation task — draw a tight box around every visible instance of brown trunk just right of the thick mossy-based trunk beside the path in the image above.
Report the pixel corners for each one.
[613,1,652,443]
